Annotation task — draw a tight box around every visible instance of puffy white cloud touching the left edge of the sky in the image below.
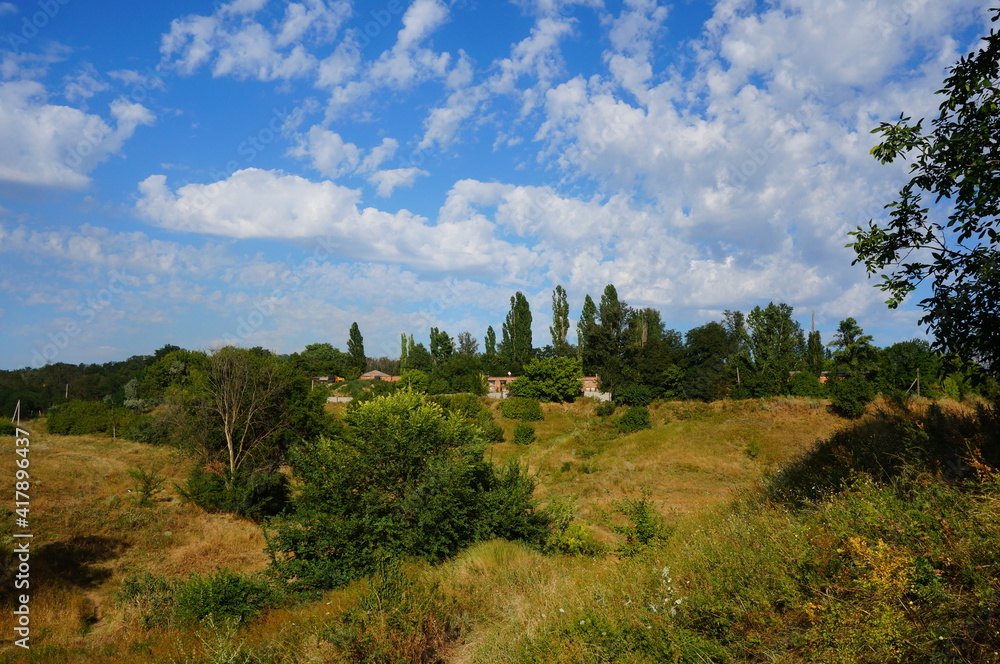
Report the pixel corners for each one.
[0,81,154,189]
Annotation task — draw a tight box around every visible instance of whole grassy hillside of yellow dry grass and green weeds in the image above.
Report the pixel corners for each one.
[0,400,1000,663]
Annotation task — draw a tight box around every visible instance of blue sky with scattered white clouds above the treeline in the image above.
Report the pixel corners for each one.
[0,0,989,369]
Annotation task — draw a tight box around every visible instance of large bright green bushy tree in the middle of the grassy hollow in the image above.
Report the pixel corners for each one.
[268,391,549,588]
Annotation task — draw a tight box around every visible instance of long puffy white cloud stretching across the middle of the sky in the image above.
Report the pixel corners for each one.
[136,168,531,274]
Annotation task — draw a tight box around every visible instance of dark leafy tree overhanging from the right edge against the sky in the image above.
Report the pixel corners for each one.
[849,8,1000,375]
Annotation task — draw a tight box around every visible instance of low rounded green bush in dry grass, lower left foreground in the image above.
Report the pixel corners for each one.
[176,569,281,624]
